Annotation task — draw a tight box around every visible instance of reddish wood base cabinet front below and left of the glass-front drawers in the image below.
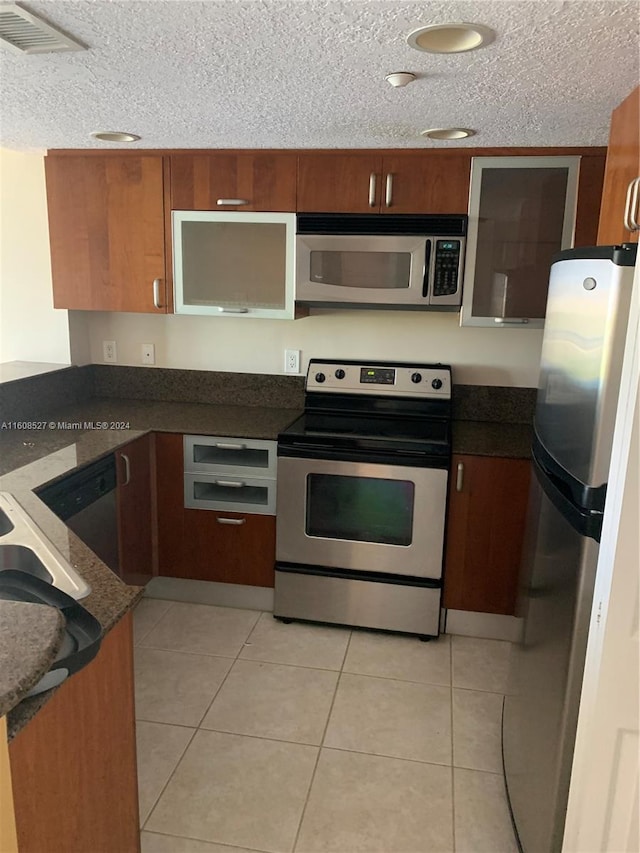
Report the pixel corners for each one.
[155,433,276,587]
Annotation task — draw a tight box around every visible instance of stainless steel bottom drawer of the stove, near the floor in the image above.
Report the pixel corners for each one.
[273,565,441,637]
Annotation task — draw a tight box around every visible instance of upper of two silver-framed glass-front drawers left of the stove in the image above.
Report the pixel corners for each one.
[184,435,276,478]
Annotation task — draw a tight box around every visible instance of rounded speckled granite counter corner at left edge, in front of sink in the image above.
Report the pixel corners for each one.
[0,601,65,717]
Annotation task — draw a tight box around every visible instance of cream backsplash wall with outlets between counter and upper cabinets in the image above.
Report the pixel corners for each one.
[77,309,542,387]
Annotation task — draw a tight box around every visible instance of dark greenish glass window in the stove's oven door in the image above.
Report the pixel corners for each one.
[306,474,415,545]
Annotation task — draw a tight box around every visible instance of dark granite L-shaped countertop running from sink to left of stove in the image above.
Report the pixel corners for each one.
[0,398,299,738]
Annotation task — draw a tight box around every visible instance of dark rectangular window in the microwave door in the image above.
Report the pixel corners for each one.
[310,250,411,290]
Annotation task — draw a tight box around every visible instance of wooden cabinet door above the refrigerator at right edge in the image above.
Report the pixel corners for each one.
[598,86,640,246]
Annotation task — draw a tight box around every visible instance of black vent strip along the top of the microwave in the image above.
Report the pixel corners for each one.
[297,213,467,237]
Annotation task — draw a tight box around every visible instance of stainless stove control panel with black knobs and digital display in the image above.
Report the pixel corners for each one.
[305,359,451,400]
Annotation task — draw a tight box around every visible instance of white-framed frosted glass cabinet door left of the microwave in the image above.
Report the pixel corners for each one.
[172,211,295,317]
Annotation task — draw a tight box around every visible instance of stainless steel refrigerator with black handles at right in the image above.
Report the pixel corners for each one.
[502,244,637,853]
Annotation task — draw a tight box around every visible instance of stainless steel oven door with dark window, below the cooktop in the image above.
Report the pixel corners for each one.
[276,457,448,579]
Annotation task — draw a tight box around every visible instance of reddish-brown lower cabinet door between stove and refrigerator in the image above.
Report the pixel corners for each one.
[444,455,531,615]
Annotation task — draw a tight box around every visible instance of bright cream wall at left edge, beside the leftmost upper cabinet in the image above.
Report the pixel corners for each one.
[0,149,70,364]
